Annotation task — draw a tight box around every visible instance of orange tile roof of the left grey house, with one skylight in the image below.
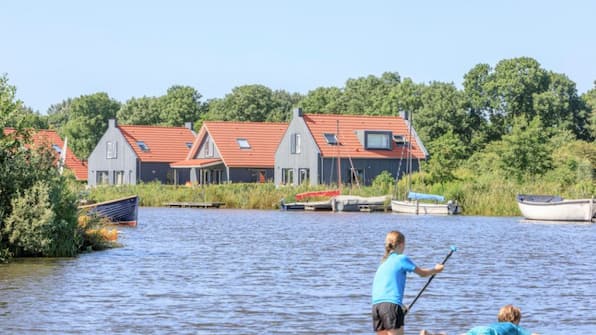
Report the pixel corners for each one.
[118,126,195,162]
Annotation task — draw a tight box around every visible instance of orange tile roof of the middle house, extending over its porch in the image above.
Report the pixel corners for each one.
[182,121,288,168]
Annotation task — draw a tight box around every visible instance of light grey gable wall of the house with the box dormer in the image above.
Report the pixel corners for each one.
[274,109,322,185]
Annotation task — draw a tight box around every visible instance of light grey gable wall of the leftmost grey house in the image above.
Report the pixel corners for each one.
[87,120,137,186]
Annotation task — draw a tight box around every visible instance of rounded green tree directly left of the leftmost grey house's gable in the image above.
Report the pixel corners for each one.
[59,93,120,159]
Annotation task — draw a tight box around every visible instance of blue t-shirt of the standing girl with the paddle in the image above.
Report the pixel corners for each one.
[372,253,416,305]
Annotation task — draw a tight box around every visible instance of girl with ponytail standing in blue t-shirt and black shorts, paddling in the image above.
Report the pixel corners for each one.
[372,231,443,335]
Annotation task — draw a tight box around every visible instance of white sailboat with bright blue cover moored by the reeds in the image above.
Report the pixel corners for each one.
[391,192,461,215]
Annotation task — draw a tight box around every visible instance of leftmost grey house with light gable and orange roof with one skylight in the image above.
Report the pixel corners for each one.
[88,119,195,186]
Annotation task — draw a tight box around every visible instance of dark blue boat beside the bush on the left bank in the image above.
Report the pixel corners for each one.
[79,195,139,227]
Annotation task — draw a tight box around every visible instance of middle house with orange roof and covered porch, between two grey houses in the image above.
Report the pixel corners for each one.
[171,121,288,184]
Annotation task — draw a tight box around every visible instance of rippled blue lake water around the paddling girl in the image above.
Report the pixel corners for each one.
[0,208,596,335]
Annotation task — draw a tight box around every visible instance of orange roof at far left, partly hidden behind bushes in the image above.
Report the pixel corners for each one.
[4,128,87,182]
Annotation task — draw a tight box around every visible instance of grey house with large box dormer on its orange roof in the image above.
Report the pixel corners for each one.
[275,109,428,185]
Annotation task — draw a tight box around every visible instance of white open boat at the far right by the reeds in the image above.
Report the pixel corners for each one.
[517,194,596,222]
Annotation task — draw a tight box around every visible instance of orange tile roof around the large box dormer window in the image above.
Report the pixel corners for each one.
[303,114,425,159]
